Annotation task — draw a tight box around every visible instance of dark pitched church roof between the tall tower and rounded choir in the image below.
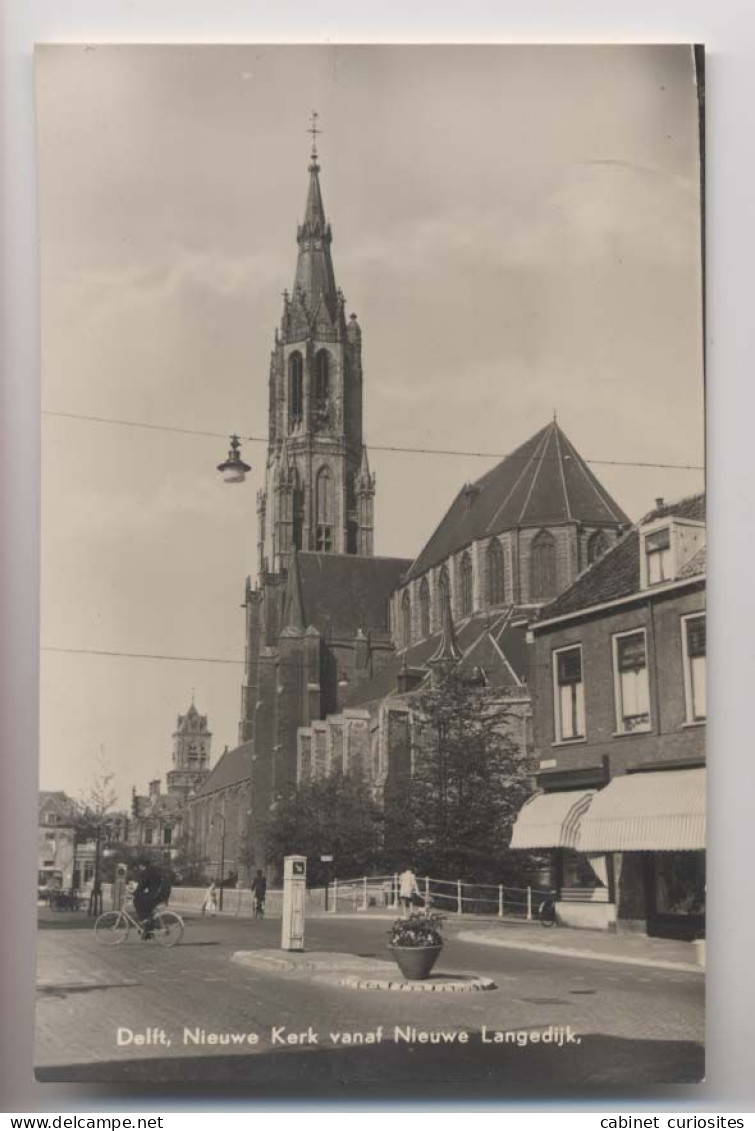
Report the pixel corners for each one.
[284,551,411,638]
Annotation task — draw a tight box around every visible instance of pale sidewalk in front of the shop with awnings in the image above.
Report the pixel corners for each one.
[454,920,705,974]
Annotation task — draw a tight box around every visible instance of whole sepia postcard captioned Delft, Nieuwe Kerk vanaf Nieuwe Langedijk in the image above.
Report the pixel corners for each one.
[35,44,706,1099]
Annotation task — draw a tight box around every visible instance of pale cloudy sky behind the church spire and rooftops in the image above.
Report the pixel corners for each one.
[37,46,704,805]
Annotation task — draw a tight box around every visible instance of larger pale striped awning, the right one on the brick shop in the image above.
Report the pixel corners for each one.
[578,768,705,852]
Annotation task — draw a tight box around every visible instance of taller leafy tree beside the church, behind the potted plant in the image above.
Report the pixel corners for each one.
[385,663,531,883]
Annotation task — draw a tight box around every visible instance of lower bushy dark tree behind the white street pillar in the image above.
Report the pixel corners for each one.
[266,771,383,887]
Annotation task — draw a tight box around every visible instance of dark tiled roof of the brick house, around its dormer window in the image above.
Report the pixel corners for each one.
[533,494,705,629]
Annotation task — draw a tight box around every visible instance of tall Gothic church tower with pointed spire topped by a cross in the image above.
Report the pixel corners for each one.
[258,114,375,584]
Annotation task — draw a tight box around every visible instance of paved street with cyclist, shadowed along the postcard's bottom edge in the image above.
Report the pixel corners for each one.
[35,918,704,1097]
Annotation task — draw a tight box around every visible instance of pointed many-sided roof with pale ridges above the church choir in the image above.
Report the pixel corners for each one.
[408,420,630,578]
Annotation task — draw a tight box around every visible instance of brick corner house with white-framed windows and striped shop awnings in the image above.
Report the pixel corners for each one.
[512,495,706,936]
